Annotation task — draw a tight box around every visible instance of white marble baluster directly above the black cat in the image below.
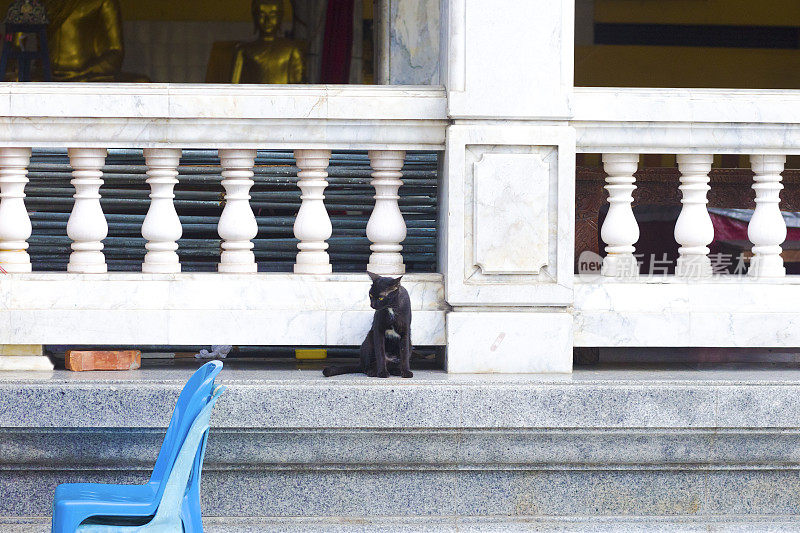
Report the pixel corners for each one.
[367,150,406,275]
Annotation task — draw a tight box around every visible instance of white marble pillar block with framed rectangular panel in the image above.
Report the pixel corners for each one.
[441,124,575,307]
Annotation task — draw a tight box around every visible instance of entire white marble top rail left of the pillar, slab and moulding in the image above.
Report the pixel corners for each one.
[0,83,448,150]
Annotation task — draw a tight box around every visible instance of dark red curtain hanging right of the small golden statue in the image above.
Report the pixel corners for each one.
[320,0,353,83]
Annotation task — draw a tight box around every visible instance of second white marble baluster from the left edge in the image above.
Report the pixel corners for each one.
[67,148,108,273]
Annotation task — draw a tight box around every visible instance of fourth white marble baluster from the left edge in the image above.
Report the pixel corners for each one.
[217,149,258,273]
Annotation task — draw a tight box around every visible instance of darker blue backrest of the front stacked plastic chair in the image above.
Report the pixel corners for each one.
[150,361,222,488]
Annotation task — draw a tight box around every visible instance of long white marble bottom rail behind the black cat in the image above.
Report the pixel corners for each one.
[0,272,447,346]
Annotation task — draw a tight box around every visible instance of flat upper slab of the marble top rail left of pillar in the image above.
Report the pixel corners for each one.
[0,83,447,120]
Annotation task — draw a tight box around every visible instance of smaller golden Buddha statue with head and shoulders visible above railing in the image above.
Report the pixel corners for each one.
[231,0,305,83]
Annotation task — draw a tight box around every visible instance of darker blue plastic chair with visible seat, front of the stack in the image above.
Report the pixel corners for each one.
[52,361,222,533]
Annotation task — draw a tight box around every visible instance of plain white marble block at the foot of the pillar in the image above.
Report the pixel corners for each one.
[447,311,573,373]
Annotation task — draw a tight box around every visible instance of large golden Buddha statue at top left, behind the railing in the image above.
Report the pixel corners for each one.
[45,0,149,82]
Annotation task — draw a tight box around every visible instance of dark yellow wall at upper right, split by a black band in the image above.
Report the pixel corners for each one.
[575,0,800,89]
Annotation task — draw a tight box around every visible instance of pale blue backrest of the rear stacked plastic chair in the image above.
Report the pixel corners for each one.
[151,385,225,525]
